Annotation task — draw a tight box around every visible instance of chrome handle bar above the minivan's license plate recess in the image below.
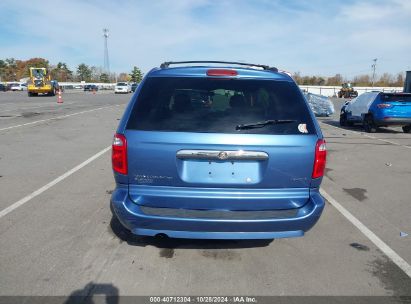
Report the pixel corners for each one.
[177,150,268,161]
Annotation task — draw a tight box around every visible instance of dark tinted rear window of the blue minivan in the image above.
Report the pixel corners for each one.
[127,77,315,134]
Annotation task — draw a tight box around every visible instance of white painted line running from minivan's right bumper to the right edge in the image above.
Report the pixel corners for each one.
[320,189,411,278]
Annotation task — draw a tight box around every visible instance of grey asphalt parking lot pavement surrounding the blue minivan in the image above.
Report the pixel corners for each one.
[0,91,411,296]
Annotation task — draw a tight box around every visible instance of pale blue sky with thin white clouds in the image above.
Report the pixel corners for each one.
[0,0,411,78]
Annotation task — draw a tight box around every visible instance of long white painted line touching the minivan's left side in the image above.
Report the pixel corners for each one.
[0,146,111,219]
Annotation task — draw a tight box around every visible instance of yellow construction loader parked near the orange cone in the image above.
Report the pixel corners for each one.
[27,68,59,96]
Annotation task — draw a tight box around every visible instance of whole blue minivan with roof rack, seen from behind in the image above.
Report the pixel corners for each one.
[111,61,326,239]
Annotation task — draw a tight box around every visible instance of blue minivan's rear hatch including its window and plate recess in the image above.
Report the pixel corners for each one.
[125,77,318,210]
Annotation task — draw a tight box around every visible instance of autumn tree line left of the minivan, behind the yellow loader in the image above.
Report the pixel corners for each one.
[0,58,143,83]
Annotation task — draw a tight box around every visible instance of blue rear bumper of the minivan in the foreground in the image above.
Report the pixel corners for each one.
[111,186,324,239]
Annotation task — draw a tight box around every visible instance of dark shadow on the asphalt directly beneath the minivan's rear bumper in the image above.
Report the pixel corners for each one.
[109,216,273,249]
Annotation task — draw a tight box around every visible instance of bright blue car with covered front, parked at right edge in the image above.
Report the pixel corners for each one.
[340,92,411,133]
